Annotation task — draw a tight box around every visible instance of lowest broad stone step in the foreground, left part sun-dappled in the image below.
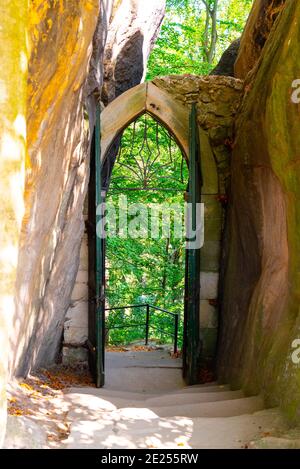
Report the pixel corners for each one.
[63,409,282,449]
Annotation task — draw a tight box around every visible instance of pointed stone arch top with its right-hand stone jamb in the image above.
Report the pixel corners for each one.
[101,82,223,366]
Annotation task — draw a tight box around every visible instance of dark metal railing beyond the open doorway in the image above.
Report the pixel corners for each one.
[105,303,179,353]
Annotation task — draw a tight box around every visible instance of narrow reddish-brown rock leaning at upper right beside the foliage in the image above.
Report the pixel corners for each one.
[234,0,286,79]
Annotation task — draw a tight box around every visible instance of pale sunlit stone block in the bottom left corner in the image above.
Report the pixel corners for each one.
[4,415,48,449]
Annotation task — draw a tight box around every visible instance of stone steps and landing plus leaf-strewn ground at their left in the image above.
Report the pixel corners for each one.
[6,350,286,449]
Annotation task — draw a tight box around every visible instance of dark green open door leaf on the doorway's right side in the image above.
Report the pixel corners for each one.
[183,104,202,385]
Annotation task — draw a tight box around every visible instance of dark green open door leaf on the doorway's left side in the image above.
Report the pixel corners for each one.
[87,106,105,388]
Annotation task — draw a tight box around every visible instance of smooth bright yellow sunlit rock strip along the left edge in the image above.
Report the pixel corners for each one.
[0,0,28,447]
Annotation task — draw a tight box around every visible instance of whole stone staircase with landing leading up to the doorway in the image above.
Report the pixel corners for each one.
[61,351,285,449]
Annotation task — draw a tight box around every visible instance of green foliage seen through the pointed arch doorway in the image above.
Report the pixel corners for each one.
[106,116,188,343]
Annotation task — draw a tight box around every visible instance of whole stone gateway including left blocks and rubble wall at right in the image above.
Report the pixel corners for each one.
[65,76,239,366]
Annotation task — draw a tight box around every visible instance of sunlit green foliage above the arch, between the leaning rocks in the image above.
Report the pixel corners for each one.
[147,0,253,80]
